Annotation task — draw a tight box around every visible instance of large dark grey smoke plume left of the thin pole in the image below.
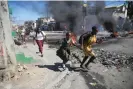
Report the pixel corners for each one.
[49,1,82,31]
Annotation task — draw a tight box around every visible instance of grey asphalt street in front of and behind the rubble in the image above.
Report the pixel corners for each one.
[47,37,133,89]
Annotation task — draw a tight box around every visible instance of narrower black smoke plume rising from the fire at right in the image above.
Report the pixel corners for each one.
[95,1,116,32]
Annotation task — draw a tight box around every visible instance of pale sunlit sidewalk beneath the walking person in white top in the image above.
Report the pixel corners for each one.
[11,43,68,89]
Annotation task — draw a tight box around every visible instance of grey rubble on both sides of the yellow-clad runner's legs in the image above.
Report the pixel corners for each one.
[72,49,133,70]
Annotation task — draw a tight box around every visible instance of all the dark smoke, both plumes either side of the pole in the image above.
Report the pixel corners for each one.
[49,1,115,33]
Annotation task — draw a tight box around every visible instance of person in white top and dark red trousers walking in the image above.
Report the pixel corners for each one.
[35,28,45,57]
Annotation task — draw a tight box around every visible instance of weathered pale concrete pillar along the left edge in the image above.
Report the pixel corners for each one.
[0,1,16,81]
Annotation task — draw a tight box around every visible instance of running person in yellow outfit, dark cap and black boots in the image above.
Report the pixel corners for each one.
[80,26,98,69]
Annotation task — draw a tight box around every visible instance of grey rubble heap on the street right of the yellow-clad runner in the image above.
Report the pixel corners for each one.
[94,49,133,67]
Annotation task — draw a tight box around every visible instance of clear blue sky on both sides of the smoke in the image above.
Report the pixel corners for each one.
[8,1,124,24]
